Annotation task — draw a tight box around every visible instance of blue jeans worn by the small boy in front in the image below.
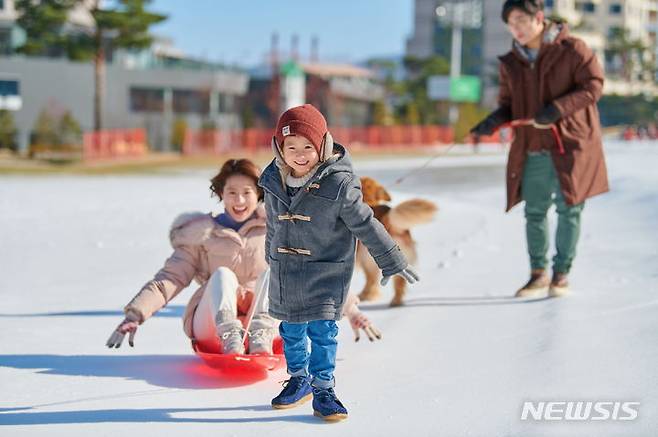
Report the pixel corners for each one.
[279,320,338,388]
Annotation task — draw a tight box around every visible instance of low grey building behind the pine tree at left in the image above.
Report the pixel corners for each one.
[0,0,249,151]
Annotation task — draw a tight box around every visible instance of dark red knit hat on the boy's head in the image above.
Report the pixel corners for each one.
[274,103,328,154]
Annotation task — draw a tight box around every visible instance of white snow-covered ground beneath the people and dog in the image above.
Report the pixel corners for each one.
[0,143,658,437]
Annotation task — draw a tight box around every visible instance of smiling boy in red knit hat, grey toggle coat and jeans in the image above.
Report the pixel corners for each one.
[259,105,418,421]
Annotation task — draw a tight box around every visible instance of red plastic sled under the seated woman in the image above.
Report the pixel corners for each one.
[192,337,286,372]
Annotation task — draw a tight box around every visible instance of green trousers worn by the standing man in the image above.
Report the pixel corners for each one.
[521,152,585,273]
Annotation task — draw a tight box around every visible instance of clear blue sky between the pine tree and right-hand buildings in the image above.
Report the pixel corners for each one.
[151,0,413,66]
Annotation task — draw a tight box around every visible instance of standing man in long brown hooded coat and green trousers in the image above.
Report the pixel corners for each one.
[471,0,608,297]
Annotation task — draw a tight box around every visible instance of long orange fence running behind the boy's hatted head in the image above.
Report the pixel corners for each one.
[182,126,454,155]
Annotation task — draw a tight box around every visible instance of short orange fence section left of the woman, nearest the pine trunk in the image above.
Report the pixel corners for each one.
[82,129,148,161]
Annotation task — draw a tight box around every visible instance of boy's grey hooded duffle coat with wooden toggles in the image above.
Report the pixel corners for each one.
[258,144,408,323]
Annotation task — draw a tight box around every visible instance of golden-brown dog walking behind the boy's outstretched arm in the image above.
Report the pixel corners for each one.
[356,177,438,306]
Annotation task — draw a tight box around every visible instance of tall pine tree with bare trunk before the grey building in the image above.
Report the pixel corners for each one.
[16,0,167,130]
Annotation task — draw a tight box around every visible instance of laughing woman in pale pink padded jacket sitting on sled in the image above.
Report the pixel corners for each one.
[106,159,381,354]
